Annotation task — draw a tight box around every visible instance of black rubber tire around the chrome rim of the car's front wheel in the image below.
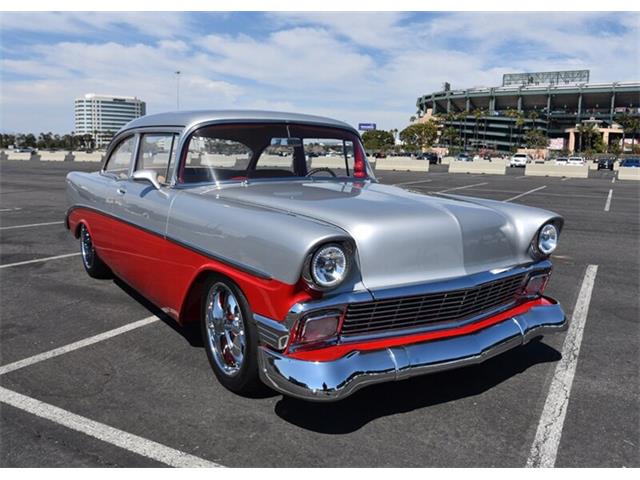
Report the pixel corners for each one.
[200,275,265,396]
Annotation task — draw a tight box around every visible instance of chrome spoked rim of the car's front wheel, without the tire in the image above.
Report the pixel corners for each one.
[205,282,247,377]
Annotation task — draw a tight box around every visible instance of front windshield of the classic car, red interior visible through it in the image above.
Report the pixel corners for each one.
[178,123,374,183]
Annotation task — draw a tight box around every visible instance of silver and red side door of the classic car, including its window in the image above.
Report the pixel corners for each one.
[113,131,178,307]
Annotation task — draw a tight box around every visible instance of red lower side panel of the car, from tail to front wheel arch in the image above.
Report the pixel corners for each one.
[68,207,312,323]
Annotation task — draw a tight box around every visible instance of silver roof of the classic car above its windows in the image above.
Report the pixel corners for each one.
[120,110,358,134]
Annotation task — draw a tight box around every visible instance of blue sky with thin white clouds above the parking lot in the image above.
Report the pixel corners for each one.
[0,12,640,133]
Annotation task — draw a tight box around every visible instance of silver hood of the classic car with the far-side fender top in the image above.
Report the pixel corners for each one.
[203,181,554,290]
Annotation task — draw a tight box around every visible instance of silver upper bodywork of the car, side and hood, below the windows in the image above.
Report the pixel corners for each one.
[67,172,557,292]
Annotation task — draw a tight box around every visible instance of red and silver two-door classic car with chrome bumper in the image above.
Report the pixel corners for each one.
[66,111,567,400]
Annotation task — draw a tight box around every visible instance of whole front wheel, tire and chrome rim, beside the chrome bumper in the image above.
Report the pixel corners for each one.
[201,276,263,395]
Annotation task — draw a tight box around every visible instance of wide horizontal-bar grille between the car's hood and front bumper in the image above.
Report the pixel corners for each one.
[342,274,526,336]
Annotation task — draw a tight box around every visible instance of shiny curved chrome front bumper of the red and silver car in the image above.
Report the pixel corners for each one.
[258,303,568,401]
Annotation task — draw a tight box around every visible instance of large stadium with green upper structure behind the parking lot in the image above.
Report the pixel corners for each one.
[416,70,640,152]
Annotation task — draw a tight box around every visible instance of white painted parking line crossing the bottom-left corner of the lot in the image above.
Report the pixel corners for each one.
[0,387,222,468]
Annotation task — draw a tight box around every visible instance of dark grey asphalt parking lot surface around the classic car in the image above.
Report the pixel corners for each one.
[0,161,640,467]
